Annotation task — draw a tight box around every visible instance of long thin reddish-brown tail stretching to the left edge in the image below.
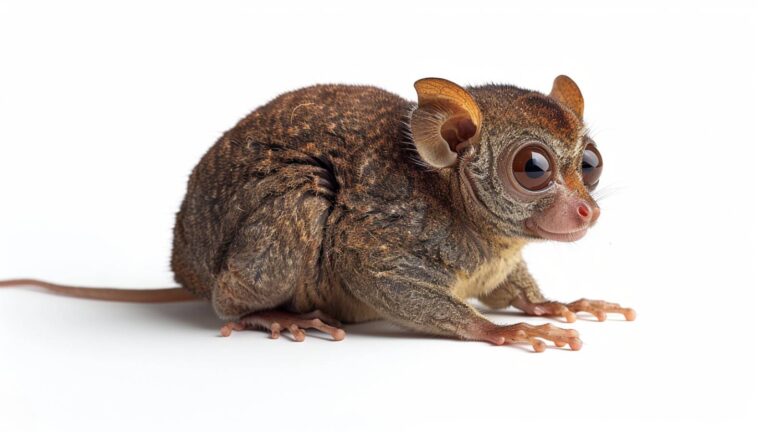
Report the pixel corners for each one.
[0,279,199,303]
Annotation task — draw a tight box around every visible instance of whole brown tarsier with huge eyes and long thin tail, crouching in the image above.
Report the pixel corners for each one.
[3,76,635,351]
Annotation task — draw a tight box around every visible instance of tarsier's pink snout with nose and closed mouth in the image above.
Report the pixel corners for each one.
[525,188,600,241]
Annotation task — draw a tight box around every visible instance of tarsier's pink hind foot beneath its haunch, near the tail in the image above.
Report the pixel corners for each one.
[221,310,346,342]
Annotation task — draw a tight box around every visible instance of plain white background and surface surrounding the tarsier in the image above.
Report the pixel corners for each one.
[0,1,766,431]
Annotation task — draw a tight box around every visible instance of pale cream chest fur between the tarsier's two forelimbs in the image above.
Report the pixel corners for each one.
[451,240,525,299]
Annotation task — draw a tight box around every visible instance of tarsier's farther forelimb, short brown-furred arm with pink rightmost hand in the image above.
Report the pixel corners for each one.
[480,262,636,323]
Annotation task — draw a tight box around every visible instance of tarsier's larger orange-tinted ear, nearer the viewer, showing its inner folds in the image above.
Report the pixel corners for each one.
[411,78,483,168]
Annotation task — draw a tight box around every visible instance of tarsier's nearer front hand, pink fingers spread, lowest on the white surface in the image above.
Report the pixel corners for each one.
[475,323,581,352]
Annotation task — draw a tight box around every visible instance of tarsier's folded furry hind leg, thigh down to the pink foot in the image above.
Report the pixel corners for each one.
[212,169,339,335]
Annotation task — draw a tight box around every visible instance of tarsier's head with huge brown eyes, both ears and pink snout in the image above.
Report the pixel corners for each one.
[411,75,603,241]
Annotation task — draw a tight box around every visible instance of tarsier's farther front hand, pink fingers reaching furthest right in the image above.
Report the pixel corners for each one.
[512,296,636,323]
